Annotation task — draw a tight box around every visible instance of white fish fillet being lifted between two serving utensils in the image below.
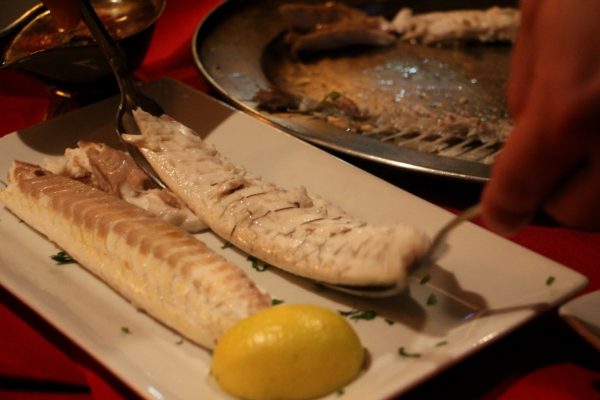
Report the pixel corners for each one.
[124,110,429,285]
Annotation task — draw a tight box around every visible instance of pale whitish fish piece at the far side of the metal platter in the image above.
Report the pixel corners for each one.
[391,7,520,44]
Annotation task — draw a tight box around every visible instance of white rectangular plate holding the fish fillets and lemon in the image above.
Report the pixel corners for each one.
[0,80,587,399]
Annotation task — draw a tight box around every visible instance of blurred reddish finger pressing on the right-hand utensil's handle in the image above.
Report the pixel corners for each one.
[482,92,582,235]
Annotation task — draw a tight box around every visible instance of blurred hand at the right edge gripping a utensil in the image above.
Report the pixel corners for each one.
[482,0,600,235]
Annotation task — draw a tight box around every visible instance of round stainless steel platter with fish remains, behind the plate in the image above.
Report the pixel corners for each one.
[192,0,515,182]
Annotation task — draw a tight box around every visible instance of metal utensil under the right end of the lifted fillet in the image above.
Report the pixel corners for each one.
[323,203,481,298]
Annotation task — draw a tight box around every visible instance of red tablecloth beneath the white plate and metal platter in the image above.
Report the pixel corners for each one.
[0,0,600,400]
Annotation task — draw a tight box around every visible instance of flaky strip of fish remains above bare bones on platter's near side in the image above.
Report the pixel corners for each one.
[252,85,513,152]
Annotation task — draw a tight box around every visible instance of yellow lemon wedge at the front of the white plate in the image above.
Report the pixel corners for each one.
[211,304,365,400]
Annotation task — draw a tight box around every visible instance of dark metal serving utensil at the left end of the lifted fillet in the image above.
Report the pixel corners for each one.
[80,0,166,188]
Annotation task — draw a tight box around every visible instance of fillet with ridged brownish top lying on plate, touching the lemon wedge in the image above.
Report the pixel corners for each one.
[0,162,271,348]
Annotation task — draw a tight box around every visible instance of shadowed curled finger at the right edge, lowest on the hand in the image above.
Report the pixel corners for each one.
[544,150,600,229]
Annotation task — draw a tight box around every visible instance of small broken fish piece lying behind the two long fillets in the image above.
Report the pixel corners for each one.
[46,141,207,233]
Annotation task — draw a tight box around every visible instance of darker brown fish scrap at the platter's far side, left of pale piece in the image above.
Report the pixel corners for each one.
[279,1,396,54]
